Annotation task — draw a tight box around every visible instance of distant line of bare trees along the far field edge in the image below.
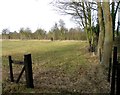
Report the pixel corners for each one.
[1,19,86,40]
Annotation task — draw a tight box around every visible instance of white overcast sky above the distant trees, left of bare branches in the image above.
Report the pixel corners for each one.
[0,0,75,32]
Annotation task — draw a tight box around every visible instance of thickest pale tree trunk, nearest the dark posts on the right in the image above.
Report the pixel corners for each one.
[102,0,113,66]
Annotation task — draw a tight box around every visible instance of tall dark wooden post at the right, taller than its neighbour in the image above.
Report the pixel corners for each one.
[110,47,117,95]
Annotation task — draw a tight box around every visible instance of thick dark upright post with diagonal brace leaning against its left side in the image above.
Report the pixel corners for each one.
[24,54,34,88]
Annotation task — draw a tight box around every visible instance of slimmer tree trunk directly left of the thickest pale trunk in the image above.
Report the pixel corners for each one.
[97,2,105,61]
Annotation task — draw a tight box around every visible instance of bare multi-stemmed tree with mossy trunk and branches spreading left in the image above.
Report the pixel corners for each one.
[52,0,96,47]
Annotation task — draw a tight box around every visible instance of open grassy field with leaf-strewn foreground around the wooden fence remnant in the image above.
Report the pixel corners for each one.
[2,40,110,93]
